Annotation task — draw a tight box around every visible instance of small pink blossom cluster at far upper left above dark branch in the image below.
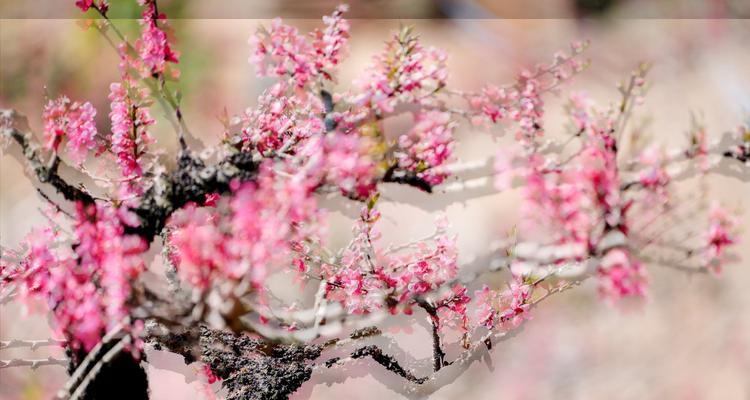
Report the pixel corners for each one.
[43,96,97,165]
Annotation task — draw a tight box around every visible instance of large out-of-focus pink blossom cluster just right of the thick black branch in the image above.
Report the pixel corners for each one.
[168,164,320,289]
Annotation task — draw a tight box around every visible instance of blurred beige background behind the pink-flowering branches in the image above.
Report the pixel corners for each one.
[0,0,750,400]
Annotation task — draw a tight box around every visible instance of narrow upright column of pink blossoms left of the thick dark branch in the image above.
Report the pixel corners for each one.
[109,82,155,178]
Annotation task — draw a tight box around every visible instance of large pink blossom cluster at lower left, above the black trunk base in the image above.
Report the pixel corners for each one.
[0,203,146,351]
